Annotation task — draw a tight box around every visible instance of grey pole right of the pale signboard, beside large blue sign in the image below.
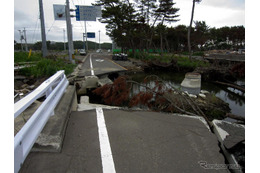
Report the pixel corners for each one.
[65,0,74,63]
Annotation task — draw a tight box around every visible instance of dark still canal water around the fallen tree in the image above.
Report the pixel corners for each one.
[129,71,245,121]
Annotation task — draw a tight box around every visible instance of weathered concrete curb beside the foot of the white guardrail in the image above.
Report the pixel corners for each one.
[31,85,77,152]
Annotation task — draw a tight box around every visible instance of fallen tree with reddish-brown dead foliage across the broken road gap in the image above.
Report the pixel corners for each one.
[93,75,230,130]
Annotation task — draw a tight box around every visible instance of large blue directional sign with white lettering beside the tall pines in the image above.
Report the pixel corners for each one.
[76,5,101,21]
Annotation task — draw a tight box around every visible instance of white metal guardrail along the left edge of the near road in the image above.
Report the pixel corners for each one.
[14,70,69,172]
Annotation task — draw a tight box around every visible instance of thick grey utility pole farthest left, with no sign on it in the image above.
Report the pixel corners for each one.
[39,0,48,57]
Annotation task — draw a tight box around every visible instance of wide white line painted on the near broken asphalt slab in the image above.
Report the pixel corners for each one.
[96,108,116,173]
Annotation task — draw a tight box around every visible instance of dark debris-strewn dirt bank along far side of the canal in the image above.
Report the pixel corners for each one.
[115,54,245,82]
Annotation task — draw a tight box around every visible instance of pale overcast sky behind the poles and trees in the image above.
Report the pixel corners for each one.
[14,0,245,43]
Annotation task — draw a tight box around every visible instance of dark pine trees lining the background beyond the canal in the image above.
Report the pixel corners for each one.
[94,0,245,52]
